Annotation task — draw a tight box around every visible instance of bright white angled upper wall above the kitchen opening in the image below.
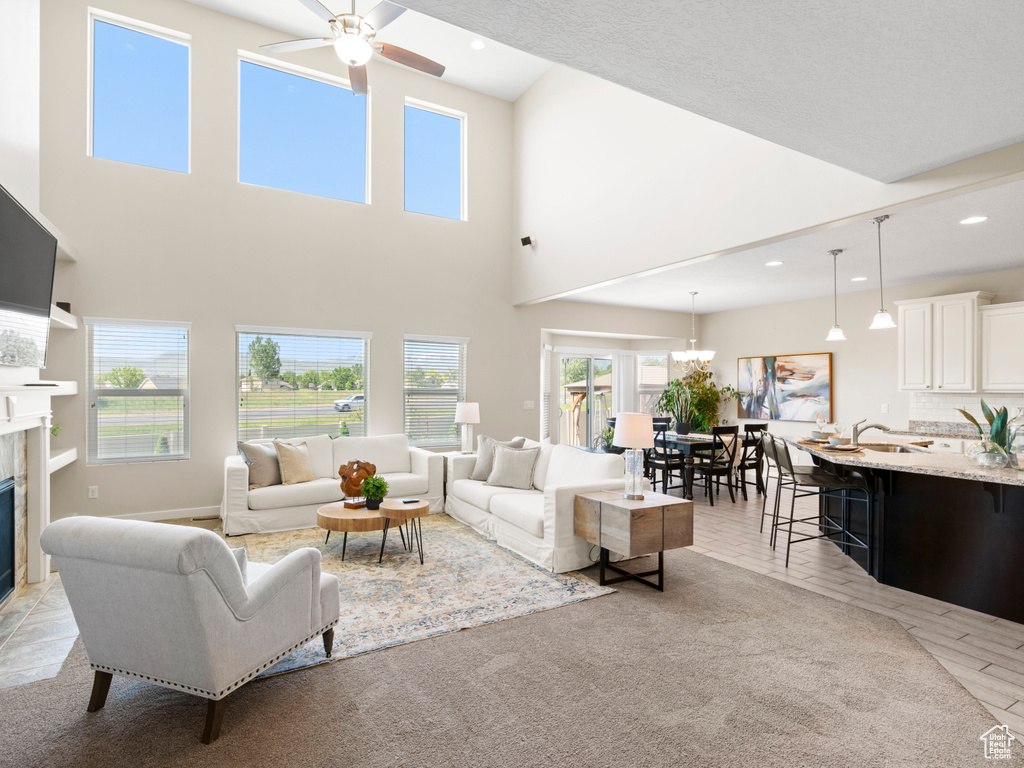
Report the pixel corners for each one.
[513,66,1024,302]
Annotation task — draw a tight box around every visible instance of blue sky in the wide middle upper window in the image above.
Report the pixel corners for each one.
[239,61,367,203]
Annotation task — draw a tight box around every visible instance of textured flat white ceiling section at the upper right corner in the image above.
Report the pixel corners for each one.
[403,0,1024,182]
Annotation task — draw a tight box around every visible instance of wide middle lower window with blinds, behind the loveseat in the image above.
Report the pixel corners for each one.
[236,326,371,440]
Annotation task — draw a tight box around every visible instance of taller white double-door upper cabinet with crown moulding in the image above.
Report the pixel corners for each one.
[896,291,993,392]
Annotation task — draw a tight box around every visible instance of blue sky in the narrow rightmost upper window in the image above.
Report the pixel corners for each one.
[406,104,462,219]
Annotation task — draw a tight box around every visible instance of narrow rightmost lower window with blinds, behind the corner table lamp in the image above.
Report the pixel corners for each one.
[404,336,469,445]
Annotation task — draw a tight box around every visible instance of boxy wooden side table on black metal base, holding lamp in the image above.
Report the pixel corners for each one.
[574,490,693,591]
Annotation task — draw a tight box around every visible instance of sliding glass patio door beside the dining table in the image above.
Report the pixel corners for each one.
[558,354,613,446]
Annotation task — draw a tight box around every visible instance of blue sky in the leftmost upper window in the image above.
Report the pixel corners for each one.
[92,18,188,173]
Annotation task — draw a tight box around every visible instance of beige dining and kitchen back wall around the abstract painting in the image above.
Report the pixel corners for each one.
[700,268,1024,434]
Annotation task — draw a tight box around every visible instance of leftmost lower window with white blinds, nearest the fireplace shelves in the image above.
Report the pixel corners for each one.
[85,317,191,464]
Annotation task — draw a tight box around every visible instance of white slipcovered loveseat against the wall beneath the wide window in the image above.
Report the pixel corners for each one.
[220,434,444,536]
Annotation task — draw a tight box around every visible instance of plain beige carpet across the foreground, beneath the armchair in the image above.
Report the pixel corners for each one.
[0,550,995,768]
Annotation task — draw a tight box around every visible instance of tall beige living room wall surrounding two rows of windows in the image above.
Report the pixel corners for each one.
[42,0,696,518]
